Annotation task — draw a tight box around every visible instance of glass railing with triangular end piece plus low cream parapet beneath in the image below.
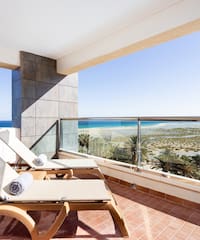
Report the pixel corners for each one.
[27,117,200,204]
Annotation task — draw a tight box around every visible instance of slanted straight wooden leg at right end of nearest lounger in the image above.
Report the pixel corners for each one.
[108,200,129,237]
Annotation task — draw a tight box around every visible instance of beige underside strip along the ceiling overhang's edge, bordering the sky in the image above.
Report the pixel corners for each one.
[57,19,200,74]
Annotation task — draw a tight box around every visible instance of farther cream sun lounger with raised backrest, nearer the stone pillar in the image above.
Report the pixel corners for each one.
[0,130,104,178]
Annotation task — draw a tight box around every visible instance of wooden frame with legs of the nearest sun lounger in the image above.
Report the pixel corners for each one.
[0,200,129,240]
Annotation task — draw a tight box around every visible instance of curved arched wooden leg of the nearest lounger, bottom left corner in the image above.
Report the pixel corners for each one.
[0,205,38,240]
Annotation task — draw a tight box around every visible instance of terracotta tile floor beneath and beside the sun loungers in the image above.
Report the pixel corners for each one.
[0,181,200,240]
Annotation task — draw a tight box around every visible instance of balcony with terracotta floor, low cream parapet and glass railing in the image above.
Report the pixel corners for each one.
[0,118,200,240]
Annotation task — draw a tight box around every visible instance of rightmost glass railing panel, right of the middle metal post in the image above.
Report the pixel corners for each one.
[141,121,200,179]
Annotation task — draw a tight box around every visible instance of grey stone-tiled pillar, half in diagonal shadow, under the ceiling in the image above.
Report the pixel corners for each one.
[12,52,78,147]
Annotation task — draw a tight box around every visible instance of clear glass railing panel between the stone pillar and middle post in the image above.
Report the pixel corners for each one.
[61,119,137,163]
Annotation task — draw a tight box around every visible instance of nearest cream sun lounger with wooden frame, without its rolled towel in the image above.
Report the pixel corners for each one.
[0,159,128,240]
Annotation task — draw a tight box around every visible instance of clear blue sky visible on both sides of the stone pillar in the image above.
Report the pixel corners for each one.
[0,32,200,120]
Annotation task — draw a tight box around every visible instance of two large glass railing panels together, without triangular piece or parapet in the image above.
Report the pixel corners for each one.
[60,117,200,179]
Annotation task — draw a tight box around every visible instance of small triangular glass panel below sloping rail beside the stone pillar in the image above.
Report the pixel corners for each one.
[31,123,57,159]
